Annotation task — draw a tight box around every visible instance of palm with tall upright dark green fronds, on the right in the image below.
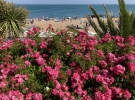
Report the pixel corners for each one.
[87,0,135,37]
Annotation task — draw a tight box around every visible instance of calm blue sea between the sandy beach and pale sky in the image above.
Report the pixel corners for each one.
[19,4,135,19]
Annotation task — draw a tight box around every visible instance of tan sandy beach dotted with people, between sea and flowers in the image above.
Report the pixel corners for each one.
[26,18,117,32]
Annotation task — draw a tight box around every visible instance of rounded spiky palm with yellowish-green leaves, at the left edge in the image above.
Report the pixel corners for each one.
[0,0,29,38]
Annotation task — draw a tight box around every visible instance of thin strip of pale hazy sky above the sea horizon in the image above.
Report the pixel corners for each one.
[6,0,135,4]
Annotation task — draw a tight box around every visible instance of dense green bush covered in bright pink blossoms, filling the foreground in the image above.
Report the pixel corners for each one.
[0,27,135,100]
